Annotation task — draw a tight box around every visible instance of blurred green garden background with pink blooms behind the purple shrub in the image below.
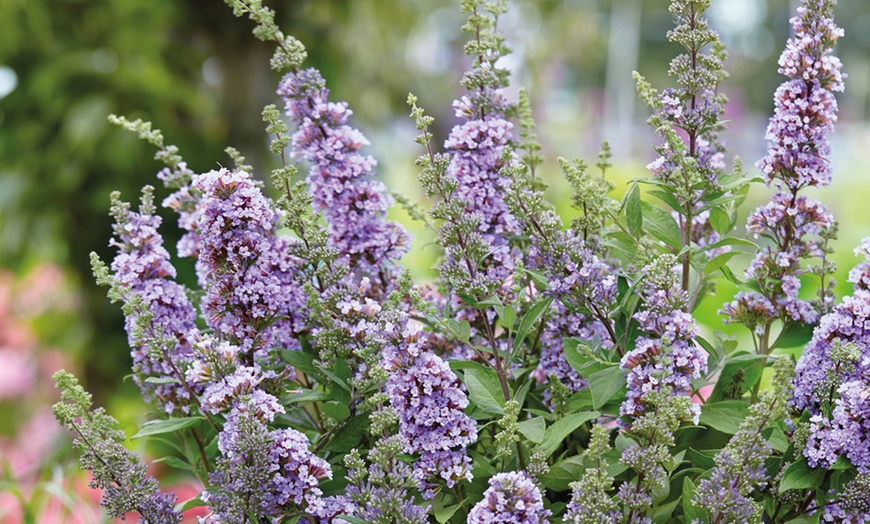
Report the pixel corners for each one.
[0,0,870,522]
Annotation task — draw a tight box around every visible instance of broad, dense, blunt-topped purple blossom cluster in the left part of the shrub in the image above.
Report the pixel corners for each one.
[192,169,307,356]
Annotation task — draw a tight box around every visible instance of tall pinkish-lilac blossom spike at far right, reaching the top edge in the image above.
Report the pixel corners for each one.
[721,0,843,333]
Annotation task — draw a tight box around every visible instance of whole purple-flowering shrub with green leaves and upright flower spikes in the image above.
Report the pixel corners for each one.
[55,0,870,524]
